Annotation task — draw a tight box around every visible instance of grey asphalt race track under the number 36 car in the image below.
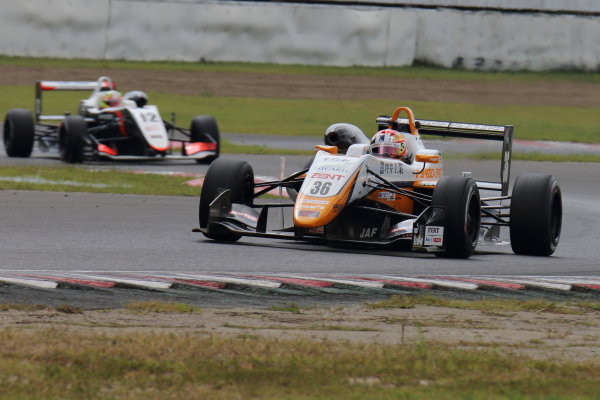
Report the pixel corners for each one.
[0,133,600,276]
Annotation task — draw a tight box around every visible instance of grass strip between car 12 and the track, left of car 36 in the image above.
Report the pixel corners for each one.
[0,166,200,196]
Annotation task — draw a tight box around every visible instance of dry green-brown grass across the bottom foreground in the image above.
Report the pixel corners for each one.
[0,327,600,400]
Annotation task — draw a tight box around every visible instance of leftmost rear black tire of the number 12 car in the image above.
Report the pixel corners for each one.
[3,108,35,157]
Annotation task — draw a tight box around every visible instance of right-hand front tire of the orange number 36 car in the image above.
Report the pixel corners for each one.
[431,176,481,258]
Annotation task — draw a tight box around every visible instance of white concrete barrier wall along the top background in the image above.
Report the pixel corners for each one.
[0,0,600,70]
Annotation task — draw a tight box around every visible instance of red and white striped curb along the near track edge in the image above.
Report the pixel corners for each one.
[0,270,600,296]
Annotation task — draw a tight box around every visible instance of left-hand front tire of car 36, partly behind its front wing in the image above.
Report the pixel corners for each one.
[199,159,254,242]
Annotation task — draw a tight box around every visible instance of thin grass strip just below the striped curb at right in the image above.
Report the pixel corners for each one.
[367,295,600,314]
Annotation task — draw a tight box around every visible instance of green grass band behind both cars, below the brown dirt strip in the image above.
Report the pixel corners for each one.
[0,85,600,144]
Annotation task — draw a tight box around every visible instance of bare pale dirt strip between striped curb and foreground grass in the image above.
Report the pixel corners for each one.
[0,305,600,361]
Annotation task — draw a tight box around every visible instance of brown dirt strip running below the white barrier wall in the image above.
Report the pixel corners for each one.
[0,65,600,107]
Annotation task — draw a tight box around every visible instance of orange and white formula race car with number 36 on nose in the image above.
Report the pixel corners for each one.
[199,107,562,258]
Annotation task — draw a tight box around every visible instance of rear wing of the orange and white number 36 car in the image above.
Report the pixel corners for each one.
[377,116,514,196]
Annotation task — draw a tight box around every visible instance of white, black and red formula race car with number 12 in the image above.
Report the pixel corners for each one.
[3,77,220,163]
